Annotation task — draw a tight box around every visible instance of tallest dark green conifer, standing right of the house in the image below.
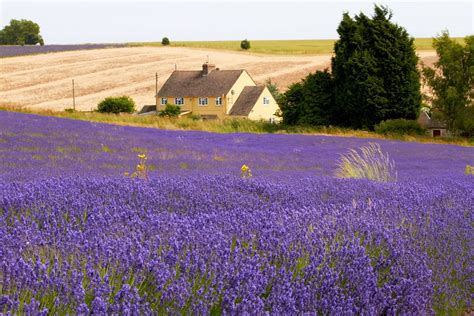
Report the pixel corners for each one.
[332,5,421,129]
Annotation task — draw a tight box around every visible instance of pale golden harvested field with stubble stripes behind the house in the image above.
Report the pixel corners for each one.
[0,47,436,110]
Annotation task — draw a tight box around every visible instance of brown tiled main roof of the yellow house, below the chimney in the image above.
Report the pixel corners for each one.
[157,69,244,97]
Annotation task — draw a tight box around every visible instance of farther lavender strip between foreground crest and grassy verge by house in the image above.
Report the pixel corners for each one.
[0,111,474,181]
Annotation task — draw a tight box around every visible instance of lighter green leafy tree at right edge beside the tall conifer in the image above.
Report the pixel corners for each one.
[422,31,474,135]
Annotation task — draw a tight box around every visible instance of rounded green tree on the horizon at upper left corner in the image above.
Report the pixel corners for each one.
[0,19,44,45]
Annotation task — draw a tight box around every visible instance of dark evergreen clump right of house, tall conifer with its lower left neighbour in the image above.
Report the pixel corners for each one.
[280,6,421,129]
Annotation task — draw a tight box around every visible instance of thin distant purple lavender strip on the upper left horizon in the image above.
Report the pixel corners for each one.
[0,44,127,58]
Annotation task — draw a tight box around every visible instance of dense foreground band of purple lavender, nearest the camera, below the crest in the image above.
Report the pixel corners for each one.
[0,176,474,314]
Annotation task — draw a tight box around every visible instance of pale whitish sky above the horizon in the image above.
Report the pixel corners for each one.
[0,0,474,44]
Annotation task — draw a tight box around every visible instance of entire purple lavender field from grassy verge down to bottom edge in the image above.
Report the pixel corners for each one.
[0,111,474,315]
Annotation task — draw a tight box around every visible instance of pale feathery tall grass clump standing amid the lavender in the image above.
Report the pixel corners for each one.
[336,143,397,182]
